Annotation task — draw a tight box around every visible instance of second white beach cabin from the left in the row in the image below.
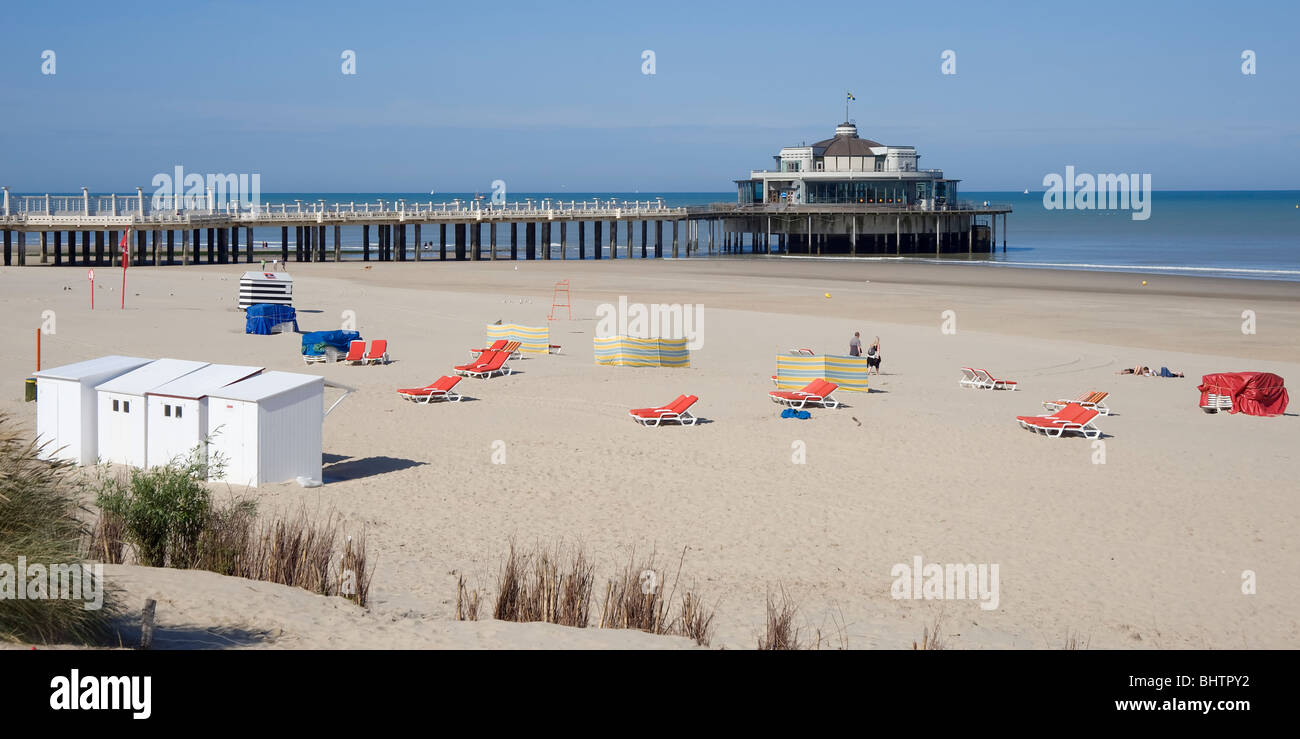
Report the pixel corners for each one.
[96,359,208,467]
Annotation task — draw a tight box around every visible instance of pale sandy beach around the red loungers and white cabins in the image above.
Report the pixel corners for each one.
[0,258,1300,649]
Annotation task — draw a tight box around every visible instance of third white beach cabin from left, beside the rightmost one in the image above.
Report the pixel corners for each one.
[144,364,263,467]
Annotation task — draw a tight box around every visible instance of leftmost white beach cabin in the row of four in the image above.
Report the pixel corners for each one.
[35,354,151,464]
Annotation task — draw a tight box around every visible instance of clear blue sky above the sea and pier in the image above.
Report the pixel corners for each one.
[0,0,1300,193]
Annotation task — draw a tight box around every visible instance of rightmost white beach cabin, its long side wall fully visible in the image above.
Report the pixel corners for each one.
[207,372,325,487]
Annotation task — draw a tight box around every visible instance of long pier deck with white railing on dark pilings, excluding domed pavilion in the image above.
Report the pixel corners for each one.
[0,187,1010,267]
